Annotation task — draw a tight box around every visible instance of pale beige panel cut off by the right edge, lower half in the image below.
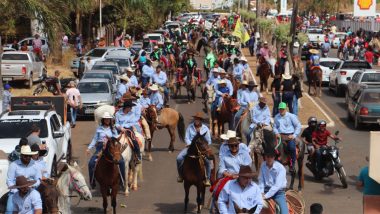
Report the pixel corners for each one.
[369,131,380,183]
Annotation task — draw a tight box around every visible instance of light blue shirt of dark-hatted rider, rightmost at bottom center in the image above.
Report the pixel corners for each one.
[259,161,287,199]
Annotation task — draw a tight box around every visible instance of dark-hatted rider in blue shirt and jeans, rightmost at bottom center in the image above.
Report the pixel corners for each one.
[259,148,289,214]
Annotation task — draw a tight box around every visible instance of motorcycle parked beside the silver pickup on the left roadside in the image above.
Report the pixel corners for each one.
[33,75,77,96]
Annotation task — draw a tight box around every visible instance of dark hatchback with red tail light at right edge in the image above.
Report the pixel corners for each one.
[347,87,380,129]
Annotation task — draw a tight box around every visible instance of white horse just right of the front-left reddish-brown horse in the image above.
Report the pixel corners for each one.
[119,132,145,196]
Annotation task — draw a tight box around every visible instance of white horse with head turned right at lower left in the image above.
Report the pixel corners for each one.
[57,163,92,214]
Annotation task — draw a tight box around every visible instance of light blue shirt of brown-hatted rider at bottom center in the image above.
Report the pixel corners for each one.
[218,179,263,214]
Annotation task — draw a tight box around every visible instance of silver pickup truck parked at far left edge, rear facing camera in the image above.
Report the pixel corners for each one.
[1,51,47,88]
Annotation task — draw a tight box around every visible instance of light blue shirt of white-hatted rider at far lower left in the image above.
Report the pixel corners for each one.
[7,160,42,192]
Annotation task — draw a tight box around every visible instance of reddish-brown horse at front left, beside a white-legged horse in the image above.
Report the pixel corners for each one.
[95,138,122,214]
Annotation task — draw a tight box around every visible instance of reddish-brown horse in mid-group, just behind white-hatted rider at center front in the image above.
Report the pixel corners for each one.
[211,97,238,136]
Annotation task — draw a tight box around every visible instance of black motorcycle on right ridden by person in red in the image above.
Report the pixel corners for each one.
[306,131,347,188]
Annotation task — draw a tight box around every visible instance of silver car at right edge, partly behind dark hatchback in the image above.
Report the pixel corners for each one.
[345,69,380,104]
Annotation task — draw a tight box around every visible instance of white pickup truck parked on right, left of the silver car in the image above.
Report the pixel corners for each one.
[329,61,372,96]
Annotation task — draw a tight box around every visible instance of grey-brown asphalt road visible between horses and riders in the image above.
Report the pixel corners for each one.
[68,49,379,214]
